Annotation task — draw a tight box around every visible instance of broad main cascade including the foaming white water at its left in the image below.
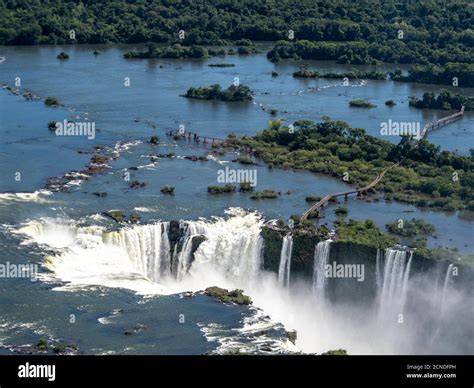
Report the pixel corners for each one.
[21,208,264,293]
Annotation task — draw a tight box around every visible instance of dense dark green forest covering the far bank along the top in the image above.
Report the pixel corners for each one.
[0,0,474,68]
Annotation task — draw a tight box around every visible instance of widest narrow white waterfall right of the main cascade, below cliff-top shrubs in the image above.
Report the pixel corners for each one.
[378,248,413,319]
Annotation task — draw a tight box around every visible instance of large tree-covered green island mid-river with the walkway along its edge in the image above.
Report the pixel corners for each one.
[222,120,474,210]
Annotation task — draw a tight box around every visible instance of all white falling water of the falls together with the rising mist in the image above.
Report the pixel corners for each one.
[15,214,466,354]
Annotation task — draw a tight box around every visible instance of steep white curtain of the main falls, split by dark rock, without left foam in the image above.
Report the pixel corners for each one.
[104,213,263,282]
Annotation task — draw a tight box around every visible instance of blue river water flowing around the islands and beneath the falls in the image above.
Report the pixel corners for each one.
[0,45,474,354]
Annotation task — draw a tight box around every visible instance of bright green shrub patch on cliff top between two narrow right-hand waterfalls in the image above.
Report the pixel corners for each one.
[334,219,399,249]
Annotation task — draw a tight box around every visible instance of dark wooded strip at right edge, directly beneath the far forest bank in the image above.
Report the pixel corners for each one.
[390,63,474,87]
